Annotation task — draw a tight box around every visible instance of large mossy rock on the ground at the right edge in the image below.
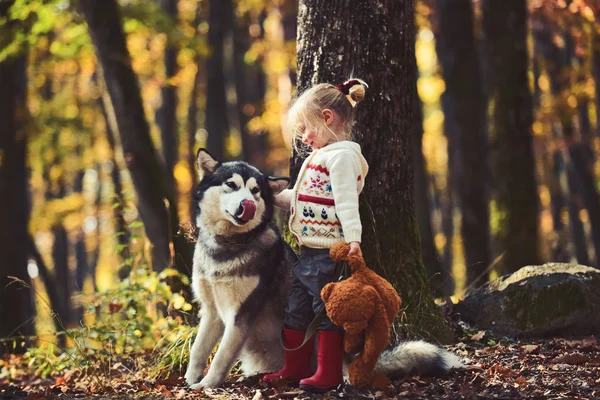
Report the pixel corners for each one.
[453,263,600,337]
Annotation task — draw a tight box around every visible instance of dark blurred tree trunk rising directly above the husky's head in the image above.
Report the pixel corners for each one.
[205,0,233,160]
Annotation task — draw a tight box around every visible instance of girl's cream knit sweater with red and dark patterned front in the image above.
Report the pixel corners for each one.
[290,141,369,248]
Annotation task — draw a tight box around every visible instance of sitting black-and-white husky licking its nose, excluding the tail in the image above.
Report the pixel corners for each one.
[185,149,295,389]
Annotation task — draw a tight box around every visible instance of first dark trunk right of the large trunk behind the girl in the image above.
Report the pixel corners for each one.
[436,0,491,285]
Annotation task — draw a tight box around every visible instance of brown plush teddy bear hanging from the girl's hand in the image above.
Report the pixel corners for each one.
[321,242,402,389]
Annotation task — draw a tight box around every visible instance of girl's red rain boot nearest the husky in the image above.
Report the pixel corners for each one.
[263,328,315,382]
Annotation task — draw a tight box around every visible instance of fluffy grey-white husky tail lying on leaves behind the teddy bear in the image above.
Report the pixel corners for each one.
[375,340,464,376]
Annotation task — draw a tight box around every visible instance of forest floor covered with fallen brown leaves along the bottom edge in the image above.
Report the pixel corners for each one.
[0,332,600,400]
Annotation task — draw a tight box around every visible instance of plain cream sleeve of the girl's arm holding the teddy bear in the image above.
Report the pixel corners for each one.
[328,151,362,242]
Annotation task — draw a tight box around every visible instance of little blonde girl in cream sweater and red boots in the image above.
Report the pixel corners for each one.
[264,79,369,391]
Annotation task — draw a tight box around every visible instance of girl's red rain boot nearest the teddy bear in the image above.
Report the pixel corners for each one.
[300,331,344,392]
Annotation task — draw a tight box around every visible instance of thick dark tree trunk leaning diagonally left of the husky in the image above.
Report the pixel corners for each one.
[79,0,174,270]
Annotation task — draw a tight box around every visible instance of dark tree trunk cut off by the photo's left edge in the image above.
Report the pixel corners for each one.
[0,20,35,350]
